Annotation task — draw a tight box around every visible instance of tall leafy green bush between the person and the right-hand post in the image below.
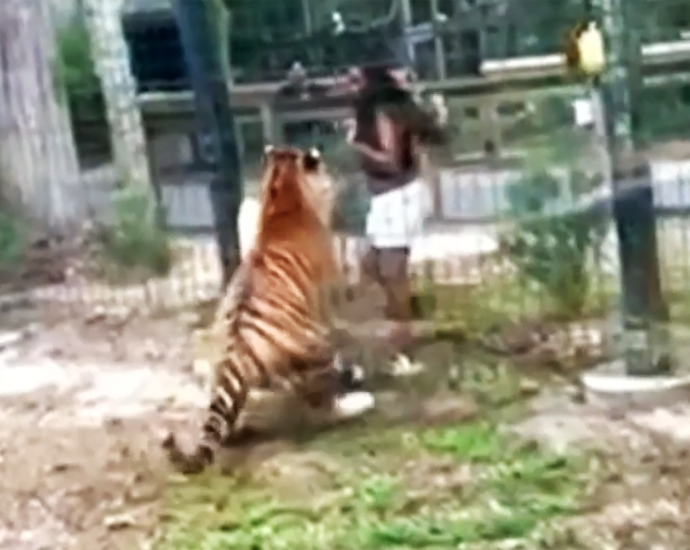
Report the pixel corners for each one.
[502,168,607,318]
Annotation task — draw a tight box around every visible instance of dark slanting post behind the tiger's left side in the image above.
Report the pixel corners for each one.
[168,0,243,285]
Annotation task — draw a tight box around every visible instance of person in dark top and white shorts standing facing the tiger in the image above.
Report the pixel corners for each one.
[347,65,446,360]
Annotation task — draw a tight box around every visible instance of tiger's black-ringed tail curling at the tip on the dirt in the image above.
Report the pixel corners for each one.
[162,359,249,475]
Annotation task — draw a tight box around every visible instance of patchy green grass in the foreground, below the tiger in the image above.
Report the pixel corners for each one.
[157,422,586,550]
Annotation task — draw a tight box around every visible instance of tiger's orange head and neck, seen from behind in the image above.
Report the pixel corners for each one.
[259,146,335,243]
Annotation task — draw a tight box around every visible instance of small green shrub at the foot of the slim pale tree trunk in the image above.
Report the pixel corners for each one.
[102,186,173,276]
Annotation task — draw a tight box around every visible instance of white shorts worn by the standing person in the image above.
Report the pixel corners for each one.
[366,178,433,248]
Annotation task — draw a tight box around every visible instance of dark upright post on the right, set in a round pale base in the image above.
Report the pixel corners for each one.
[596,0,670,375]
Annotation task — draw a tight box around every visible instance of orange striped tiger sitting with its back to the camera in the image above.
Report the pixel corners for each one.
[162,147,375,475]
